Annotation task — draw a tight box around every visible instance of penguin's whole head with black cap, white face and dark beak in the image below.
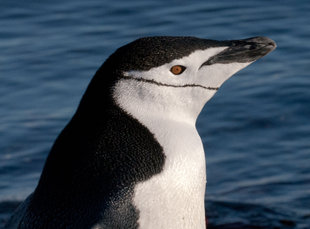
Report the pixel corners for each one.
[102,37,276,122]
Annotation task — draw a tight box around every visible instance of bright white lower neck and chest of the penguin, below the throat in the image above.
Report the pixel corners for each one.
[134,117,206,229]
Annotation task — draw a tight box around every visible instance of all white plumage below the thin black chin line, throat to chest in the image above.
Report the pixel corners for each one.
[113,81,208,228]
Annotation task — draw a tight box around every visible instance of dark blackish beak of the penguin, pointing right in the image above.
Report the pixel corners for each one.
[200,37,277,68]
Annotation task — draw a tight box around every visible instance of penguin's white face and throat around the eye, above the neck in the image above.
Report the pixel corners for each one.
[114,47,250,123]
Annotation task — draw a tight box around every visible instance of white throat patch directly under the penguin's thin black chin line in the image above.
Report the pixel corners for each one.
[113,78,216,125]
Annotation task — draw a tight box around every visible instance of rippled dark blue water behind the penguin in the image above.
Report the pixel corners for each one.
[0,0,310,229]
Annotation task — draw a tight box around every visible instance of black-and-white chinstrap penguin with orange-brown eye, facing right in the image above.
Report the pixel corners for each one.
[5,37,276,229]
